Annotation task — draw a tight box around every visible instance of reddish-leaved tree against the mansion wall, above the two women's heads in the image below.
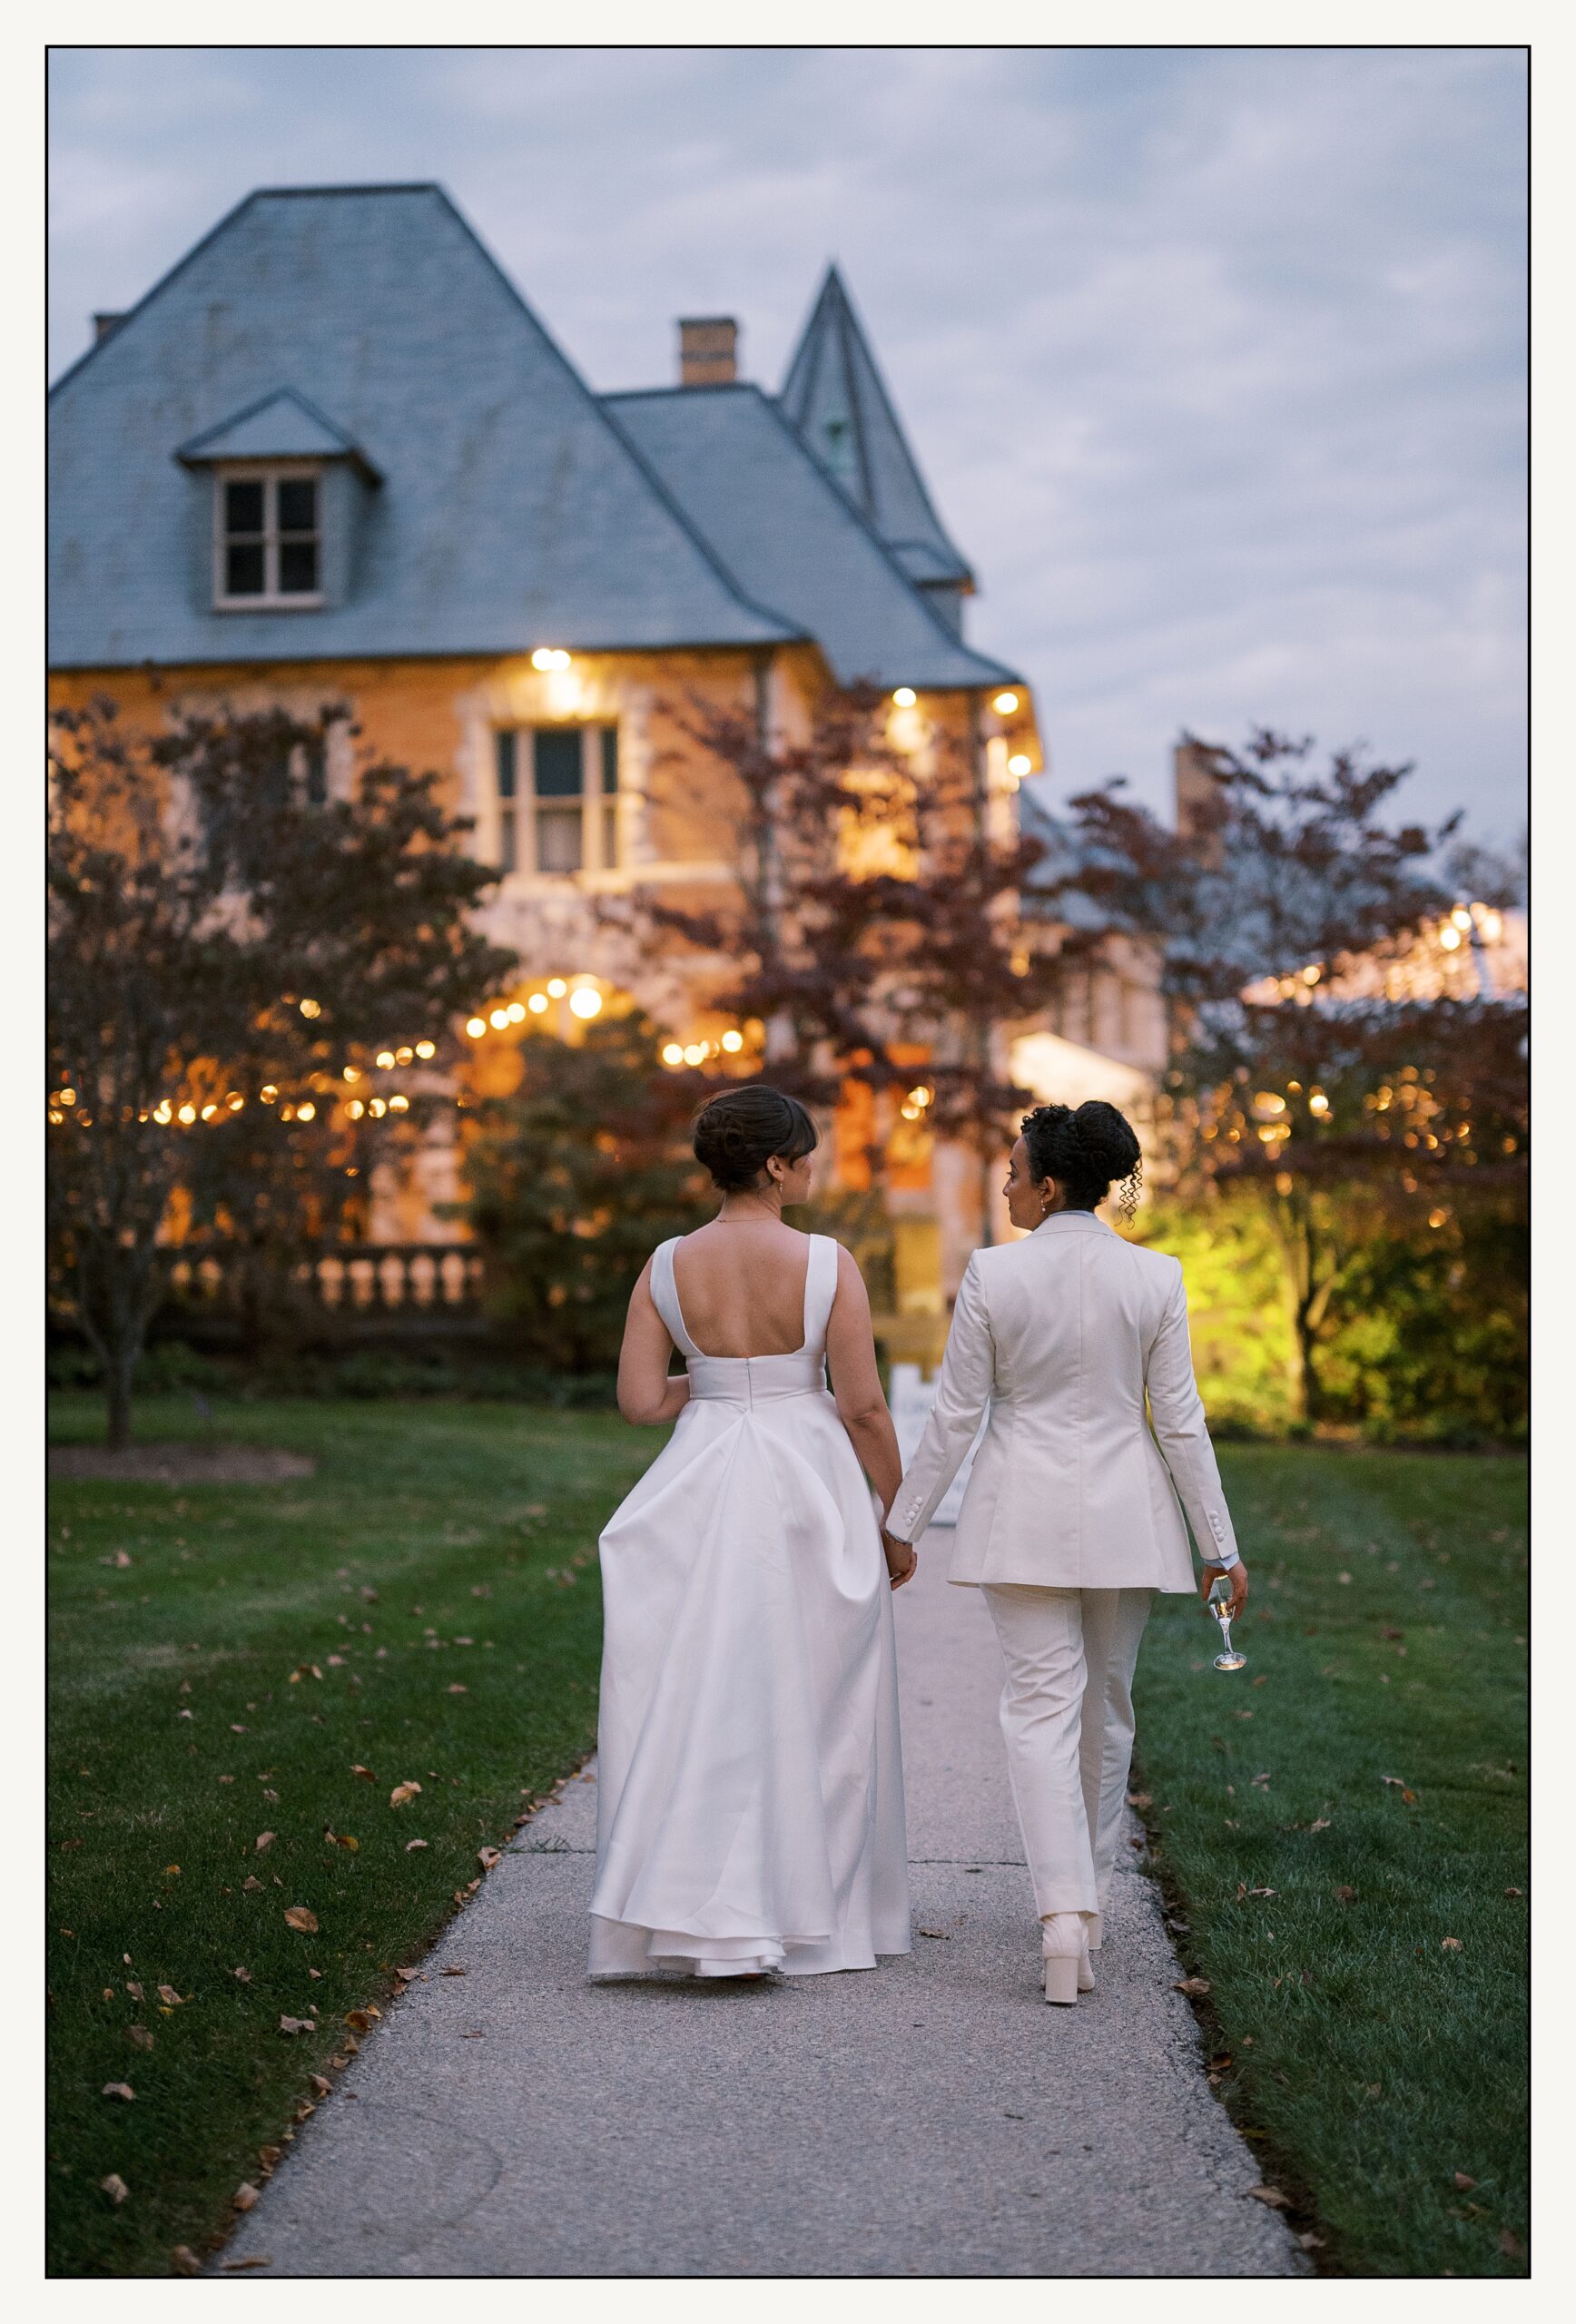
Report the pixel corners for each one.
[609,688,1062,1171]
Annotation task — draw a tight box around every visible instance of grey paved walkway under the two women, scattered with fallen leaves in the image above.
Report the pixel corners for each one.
[221,1534,1306,2275]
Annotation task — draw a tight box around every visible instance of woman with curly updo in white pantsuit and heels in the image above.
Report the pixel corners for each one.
[886,1101,1248,2004]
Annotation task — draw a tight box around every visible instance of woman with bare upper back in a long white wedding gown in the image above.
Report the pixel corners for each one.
[590,1083,913,1978]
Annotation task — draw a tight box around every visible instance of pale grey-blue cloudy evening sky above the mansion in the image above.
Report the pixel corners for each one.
[51,49,1525,839]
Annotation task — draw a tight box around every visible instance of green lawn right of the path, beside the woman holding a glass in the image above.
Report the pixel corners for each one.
[1135,1448,1527,2275]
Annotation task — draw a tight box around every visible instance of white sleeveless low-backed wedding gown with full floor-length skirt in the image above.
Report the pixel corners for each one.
[590,1234,909,1978]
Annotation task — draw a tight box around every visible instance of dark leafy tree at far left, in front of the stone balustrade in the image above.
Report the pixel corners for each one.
[49,702,511,1443]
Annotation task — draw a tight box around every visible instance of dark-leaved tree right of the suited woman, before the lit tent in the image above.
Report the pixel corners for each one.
[1060,732,1527,1418]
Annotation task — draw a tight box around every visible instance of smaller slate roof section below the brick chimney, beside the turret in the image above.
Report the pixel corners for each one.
[605,383,1023,688]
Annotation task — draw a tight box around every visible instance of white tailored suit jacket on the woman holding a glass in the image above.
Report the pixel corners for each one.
[886,1211,1236,1590]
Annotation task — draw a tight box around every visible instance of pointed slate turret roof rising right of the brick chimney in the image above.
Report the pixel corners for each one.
[779,267,971,588]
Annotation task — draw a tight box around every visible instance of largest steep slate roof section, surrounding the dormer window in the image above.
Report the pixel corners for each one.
[49,186,795,667]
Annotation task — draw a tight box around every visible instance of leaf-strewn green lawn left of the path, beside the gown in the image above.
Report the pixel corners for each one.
[49,1397,663,2275]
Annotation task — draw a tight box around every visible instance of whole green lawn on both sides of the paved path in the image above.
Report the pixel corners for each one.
[49,1397,1527,2275]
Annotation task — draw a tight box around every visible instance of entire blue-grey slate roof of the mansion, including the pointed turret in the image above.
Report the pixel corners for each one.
[49,186,1020,688]
